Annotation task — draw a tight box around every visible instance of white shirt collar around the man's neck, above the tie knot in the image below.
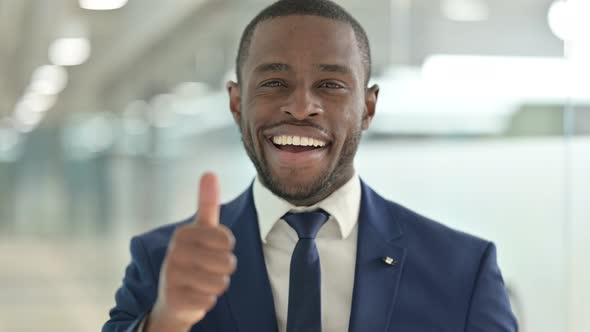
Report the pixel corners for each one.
[253,172,361,243]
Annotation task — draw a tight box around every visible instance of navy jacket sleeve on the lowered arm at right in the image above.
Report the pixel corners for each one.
[465,243,518,332]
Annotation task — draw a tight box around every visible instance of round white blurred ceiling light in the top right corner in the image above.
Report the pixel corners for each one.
[547,0,590,42]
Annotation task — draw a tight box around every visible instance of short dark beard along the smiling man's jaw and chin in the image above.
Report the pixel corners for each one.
[240,118,362,204]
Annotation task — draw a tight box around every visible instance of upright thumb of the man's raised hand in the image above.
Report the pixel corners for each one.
[195,173,219,227]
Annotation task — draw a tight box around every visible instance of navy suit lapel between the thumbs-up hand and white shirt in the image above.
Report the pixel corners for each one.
[221,186,278,332]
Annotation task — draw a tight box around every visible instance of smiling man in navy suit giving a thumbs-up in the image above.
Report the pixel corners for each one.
[103,0,516,332]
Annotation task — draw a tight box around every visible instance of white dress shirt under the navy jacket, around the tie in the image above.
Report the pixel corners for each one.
[253,174,361,332]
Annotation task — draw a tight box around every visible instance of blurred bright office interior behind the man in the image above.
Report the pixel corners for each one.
[0,0,590,332]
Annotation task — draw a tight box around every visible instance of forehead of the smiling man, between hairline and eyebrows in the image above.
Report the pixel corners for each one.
[243,15,362,76]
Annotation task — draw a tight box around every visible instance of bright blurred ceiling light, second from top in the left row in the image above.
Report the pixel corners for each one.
[49,37,90,66]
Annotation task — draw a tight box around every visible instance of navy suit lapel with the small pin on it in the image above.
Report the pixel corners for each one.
[349,182,406,332]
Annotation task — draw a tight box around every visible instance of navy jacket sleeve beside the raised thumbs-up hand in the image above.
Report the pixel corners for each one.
[102,237,158,332]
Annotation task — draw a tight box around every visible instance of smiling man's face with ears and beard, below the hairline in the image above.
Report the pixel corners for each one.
[228,16,378,205]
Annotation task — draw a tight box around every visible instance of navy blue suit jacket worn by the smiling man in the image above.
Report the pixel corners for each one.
[102,183,517,332]
